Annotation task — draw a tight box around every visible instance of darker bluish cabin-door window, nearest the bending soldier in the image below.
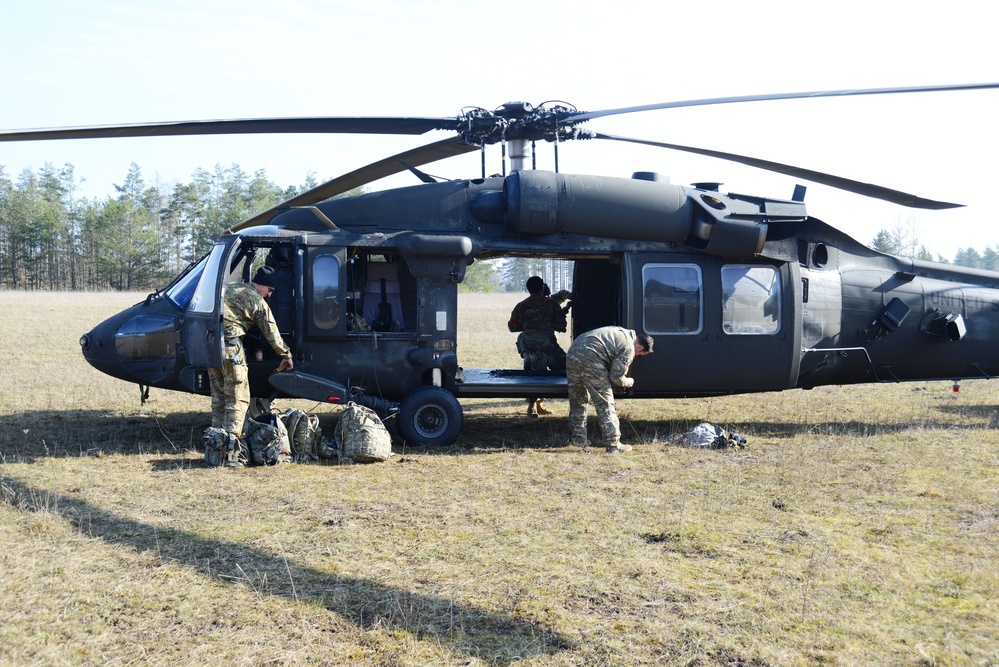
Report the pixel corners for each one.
[642,264,704,334]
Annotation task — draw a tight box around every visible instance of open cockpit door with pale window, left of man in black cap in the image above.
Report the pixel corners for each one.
[181,237,239,376]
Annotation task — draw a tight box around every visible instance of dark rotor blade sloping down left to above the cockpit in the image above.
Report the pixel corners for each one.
[228,137,479,232]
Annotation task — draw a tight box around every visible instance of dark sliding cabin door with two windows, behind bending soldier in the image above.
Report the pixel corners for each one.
[623,253,801,396]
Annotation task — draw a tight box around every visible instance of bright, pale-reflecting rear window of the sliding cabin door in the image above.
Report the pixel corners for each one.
[722,264,781,336]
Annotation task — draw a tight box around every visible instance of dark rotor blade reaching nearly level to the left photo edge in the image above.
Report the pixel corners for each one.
[0,117,460,141]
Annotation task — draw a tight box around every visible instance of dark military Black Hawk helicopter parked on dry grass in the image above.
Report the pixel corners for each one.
[0,83,999,445]
